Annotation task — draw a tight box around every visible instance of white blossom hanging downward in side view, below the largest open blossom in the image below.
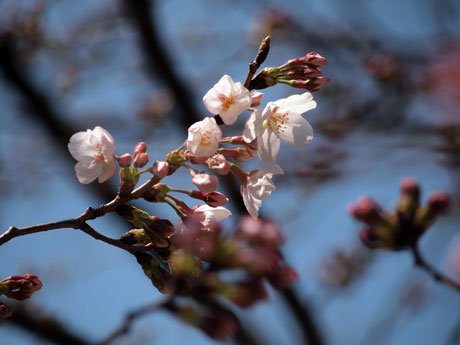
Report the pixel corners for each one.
[241,165,284,218]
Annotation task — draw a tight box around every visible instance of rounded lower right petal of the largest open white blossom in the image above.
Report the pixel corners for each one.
[278,112,313,147]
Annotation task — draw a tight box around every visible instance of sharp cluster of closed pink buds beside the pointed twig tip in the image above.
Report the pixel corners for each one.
[250,52,329,92]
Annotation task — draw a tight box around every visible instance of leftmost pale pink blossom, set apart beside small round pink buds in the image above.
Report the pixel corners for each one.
[67,126,117,184]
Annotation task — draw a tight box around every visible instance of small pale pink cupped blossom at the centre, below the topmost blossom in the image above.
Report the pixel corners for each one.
[187,117,222,157]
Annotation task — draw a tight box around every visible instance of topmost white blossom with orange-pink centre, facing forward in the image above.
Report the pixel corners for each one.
[203,75,252,125]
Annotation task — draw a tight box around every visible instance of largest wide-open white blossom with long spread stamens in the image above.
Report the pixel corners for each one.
[243,92,316,163]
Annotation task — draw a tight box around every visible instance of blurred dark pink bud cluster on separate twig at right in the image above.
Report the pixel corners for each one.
[348,178,450,250]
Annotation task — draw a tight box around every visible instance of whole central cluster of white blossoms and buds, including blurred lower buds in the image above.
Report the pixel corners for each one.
[64,38,326,339]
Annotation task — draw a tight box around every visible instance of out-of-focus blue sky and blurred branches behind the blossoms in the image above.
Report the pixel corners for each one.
[0,0,460,345]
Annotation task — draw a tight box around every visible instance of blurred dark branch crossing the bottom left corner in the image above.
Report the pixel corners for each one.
[4,303,94,345]
